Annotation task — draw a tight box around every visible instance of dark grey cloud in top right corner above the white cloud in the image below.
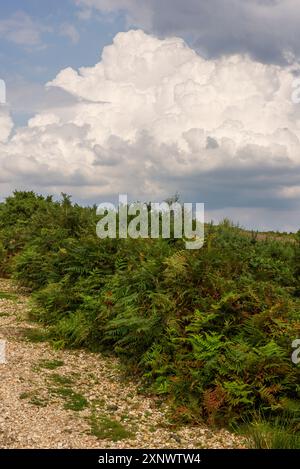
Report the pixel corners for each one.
[75,0,300,64]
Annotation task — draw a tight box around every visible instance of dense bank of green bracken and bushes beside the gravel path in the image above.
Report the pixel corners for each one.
[0,192,300,436]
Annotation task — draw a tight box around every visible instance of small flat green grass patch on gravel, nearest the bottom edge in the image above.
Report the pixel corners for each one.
[90,413,134,442]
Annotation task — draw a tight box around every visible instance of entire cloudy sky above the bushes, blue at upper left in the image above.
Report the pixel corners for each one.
[0,0,300,231]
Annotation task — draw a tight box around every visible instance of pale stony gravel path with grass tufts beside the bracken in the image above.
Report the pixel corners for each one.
[0,279,243,449]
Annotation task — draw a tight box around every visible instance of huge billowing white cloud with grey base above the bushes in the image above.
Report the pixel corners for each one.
[0,30,300,229]
